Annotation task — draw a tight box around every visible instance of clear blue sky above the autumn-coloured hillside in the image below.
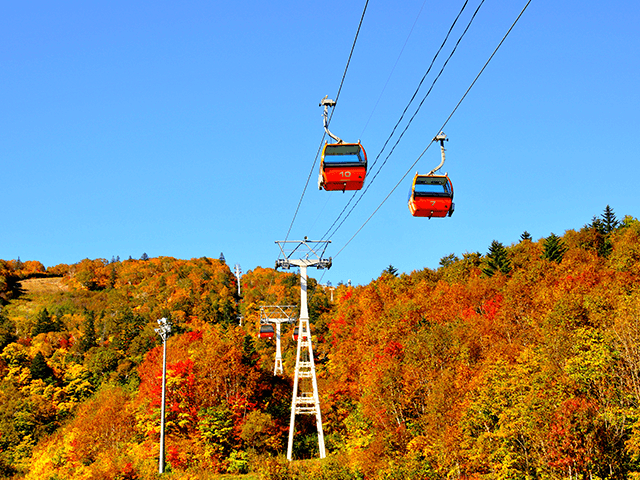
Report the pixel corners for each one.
[0,0,640,284]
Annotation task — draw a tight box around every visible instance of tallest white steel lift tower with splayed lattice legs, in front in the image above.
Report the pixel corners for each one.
[276,237,331,461]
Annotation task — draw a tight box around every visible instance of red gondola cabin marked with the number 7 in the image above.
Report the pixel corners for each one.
[409,173,455,218]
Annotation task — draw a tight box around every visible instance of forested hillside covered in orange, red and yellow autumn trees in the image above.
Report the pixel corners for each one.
[0,208,640,479]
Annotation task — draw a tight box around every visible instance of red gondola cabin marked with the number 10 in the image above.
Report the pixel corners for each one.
[318,142,367,192]
